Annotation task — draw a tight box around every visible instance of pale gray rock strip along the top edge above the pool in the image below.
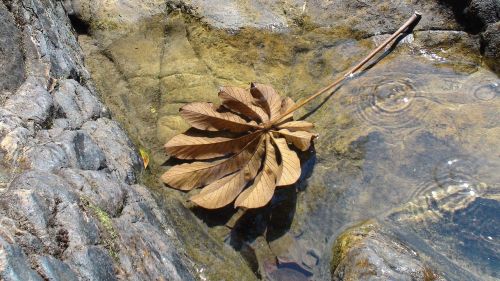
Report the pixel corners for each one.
[166,0,458,36]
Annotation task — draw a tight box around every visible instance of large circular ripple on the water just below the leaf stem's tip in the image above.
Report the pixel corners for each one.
[354,77,426,129]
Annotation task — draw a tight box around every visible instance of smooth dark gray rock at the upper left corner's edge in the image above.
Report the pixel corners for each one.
[0,2,24,92]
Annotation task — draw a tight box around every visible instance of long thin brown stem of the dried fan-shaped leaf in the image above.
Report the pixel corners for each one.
[270,12,421,125]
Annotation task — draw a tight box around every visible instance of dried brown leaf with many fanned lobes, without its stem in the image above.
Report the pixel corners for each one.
[166,84,314,209]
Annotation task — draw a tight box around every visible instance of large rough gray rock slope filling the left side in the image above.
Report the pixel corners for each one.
[0,0,194,281]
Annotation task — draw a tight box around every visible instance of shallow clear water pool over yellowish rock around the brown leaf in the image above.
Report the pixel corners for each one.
[81,13,500,280]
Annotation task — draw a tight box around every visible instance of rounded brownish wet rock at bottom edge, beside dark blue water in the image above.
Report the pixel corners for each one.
[331,222,444,281]
